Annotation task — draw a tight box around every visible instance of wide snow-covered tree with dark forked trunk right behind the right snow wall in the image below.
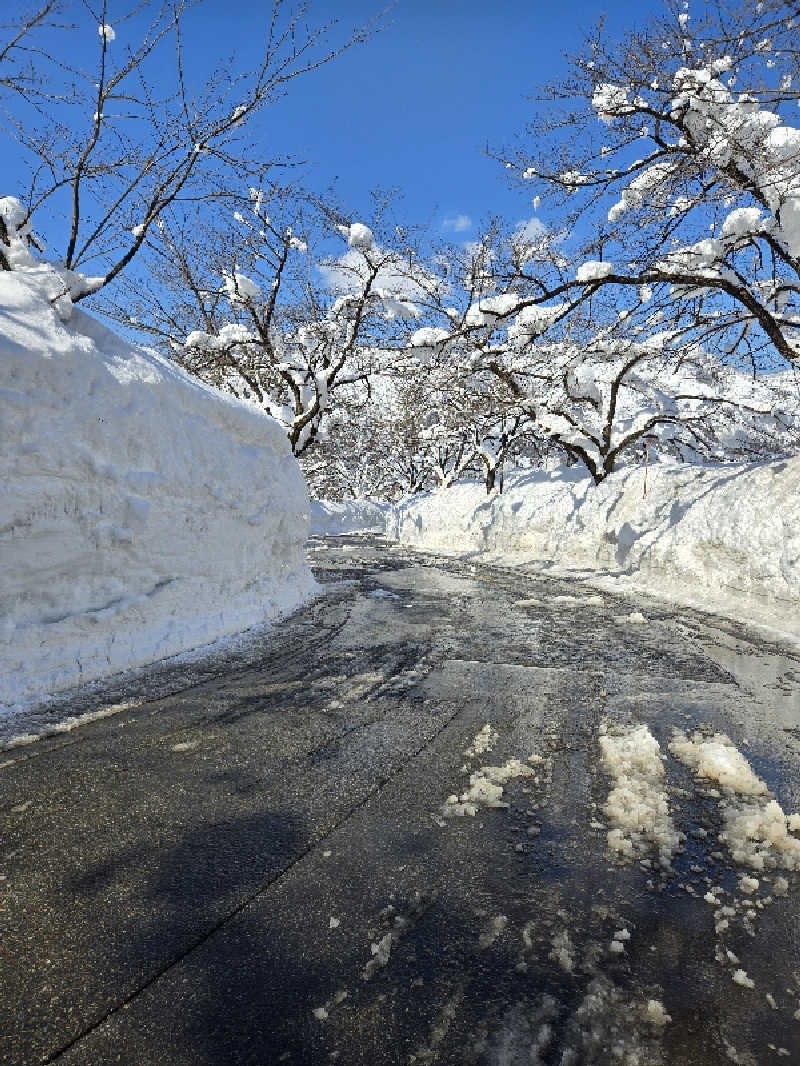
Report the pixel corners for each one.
[394,227,800,483]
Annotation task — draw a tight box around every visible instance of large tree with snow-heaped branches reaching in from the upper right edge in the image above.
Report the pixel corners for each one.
[499,0,800,367]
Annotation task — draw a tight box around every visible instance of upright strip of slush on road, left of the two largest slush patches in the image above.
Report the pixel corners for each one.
[599,725,681,869]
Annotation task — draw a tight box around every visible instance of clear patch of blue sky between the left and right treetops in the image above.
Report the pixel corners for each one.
[203,0,661,239]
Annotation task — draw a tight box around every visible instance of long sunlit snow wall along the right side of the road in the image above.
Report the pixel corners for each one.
[386,458,800,636]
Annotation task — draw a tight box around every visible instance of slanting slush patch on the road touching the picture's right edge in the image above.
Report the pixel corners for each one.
[670,733,800,874]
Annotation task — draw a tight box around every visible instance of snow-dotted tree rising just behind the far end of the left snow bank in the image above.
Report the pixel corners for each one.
[125,198,439,455]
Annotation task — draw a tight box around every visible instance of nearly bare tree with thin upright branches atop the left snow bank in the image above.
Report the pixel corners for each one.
[0,0,379,302]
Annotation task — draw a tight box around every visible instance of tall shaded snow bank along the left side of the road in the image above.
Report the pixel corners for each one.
[0,268,315,708]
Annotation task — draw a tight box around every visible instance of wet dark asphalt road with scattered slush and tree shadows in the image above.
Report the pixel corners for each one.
[0,536,800,1066]
